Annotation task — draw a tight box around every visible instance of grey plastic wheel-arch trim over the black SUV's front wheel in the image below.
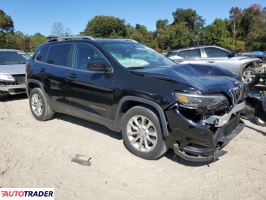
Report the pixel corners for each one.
[113,96,169,136]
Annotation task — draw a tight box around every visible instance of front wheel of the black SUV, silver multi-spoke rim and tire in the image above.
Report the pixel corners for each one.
[122,106,167,160]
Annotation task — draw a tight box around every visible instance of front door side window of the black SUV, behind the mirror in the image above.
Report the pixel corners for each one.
[75,43,108,70]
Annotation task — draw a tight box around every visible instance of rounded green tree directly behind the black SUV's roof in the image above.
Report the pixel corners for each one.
[80,16,127,38]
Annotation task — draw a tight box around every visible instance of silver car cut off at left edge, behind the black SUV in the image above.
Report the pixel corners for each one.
[0,49,29,99]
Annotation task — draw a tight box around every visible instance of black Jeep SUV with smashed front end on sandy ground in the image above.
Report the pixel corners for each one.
[26,37,246,161]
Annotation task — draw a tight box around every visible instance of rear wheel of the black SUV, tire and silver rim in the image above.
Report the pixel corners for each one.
[29,88,54,121]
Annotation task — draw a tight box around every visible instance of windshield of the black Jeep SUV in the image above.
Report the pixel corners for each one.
[103,42,175,68]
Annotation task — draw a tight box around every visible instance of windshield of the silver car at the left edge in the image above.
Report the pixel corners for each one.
[0,51,30,65]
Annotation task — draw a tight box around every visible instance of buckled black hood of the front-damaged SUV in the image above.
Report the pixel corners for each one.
[135,64,242,94]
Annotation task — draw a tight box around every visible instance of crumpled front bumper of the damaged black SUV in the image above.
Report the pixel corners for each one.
[166,102,245,162]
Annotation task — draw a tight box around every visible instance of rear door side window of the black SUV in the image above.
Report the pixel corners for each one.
[47,44,71,66]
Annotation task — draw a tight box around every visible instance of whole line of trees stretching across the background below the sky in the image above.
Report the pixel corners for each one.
[0,4,266,52]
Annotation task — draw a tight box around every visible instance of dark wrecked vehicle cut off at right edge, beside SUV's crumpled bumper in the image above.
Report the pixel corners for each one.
[246,73,266,126]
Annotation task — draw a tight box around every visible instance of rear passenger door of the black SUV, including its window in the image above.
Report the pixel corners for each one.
[39,43,73,112]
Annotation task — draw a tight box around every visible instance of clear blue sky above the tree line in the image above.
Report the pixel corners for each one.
[0,0,266,36]
